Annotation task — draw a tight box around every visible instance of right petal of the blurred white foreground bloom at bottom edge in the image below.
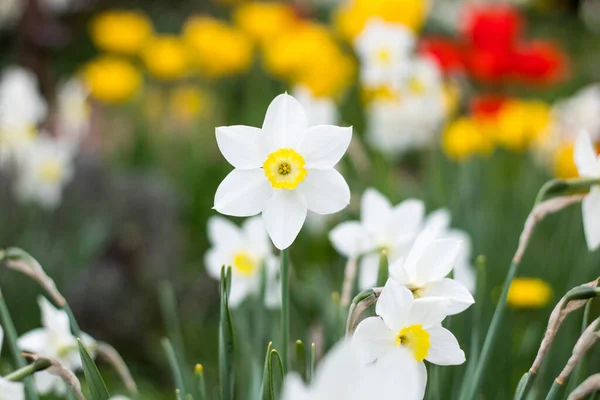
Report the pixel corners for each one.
[362,346,427,400]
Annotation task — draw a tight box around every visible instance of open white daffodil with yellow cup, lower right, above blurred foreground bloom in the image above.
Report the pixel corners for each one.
[353,279,465,390]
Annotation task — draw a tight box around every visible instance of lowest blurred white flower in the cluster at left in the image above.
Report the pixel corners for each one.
[15,136,73,209]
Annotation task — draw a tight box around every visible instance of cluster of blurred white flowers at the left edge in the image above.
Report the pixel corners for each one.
[0,68,89,209]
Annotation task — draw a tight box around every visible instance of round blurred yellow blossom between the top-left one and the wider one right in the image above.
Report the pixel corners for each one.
[142,35,189,79]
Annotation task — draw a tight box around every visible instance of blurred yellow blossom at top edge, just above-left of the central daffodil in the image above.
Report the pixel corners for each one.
[234,2,298,43]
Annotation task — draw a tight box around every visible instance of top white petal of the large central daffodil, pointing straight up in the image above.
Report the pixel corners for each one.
[263,93,308,152]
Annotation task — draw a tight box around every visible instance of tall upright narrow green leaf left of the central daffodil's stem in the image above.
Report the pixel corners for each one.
[219,266,235,400]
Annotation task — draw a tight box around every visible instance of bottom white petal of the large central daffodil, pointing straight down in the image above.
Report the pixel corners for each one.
[263,189,307,250]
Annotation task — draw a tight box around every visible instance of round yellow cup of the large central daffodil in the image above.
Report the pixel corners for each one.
[263,149,306,189]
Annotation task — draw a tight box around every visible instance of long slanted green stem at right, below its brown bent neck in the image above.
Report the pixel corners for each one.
[463,261,519,400]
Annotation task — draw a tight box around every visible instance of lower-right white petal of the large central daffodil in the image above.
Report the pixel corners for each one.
[296,168,350,215]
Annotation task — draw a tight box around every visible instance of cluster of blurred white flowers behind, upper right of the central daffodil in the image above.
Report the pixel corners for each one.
[354,19,446,157]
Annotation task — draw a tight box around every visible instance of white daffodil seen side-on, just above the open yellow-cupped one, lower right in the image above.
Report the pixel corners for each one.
[390,227,475,315]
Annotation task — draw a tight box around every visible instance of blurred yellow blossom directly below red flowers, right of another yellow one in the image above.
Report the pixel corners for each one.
[493,99,550,151]
